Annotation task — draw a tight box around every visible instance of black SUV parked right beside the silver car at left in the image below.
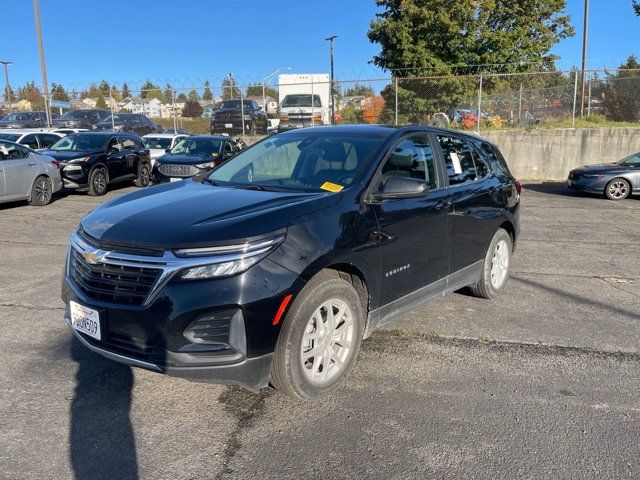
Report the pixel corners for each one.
[42,132,151,195]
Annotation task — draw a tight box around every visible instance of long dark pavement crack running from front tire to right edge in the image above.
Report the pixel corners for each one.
[367,329,640,362]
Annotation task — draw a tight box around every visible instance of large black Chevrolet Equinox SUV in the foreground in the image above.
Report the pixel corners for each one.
[62,125,520,398]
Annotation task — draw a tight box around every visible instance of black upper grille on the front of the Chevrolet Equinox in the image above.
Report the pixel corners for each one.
[69,248,162,305]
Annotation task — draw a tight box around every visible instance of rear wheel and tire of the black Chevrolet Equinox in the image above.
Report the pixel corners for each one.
[469,228,513,299]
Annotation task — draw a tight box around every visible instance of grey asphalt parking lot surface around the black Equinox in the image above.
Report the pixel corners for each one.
[0,184,640,479]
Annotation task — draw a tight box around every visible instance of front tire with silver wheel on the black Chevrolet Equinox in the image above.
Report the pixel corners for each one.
[271,270,365,400]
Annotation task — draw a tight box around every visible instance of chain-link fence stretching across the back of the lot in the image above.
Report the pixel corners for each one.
[3,69,640,133]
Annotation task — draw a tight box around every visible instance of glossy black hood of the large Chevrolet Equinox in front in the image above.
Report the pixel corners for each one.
[82,179,342,250]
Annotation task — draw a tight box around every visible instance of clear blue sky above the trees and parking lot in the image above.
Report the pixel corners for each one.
[5,0,640,91]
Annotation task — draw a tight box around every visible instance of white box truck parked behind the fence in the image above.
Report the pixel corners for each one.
[278,73,331,132]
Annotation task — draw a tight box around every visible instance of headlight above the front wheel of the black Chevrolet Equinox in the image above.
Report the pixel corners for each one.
[175,235,284,280]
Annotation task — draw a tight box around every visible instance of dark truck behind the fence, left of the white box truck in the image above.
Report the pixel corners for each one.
[211,100,269,135]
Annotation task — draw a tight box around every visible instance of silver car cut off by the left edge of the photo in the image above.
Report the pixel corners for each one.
[0,140,62,205]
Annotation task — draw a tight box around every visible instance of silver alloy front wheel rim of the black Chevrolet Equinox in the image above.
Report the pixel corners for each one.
[300,298,355,385]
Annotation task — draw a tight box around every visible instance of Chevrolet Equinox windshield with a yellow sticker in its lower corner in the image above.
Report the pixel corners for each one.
[208,133,384,192]
